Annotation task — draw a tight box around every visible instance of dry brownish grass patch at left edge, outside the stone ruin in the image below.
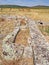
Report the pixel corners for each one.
[0,20,15,39]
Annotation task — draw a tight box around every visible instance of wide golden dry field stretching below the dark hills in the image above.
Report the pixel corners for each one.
[0,8,49,22]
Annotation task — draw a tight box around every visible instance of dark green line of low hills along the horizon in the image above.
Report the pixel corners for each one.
[0,5,49,9]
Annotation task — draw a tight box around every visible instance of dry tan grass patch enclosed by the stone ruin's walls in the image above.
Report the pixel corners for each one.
[15,29,30,46]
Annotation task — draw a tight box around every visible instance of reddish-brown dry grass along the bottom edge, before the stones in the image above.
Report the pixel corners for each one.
[1,58,34,65]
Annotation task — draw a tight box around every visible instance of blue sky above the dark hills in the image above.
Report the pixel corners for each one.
[0,0,49,6]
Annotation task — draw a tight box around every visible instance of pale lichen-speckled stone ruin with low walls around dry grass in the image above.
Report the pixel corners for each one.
[1,16,49,65]
